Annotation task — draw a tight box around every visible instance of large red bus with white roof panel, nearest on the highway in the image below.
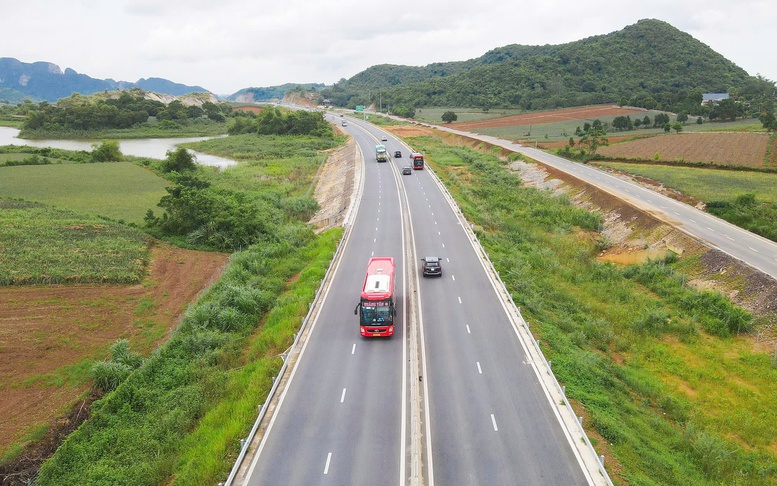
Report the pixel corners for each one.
[353,257,396,337]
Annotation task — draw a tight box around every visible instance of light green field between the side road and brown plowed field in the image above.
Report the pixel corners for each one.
[597,162,777,204]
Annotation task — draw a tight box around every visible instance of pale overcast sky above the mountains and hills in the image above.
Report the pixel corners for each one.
[0,0,777,95]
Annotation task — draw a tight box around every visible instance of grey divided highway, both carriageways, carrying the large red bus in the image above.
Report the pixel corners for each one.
[242,117,607,485]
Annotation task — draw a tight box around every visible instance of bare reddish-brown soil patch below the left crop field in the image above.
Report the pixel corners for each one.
[0,243,228,464]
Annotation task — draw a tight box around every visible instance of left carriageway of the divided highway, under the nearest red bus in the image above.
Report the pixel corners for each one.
[243,116,407,486]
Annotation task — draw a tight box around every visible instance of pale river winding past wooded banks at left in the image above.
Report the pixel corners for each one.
[0,127,237,168]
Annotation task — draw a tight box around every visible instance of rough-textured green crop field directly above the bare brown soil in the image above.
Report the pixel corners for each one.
[0,199,148,285]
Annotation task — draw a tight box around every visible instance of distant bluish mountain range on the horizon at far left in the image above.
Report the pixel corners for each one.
[0,57,208,103]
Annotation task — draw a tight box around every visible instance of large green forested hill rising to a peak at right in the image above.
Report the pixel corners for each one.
[322,19,774,110]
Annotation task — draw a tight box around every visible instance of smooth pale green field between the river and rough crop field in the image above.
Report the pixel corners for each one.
[0,162,168,224]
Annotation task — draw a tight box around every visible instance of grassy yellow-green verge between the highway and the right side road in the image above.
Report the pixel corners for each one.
[411,137,777,485]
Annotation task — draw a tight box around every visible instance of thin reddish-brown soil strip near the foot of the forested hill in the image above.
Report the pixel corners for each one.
[451,105,647,131]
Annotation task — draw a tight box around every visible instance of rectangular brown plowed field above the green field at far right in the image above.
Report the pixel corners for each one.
[597,133,769,167]
